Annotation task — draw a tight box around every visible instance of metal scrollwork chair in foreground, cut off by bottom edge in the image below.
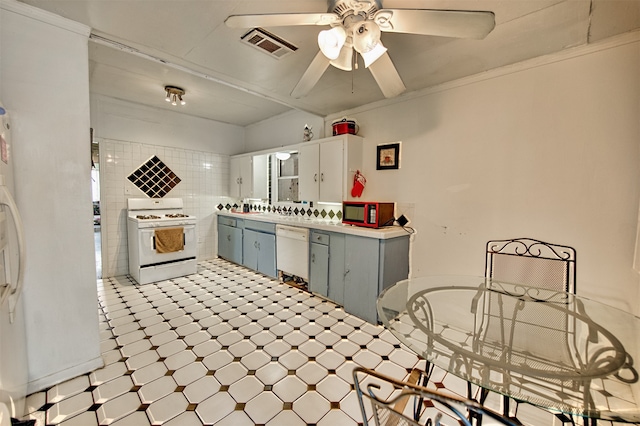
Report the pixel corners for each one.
[353,367,517,426]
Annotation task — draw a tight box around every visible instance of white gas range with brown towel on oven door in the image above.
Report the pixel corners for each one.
[127,198,198,284]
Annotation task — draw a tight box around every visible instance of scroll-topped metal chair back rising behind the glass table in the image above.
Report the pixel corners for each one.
[485,238,576,294]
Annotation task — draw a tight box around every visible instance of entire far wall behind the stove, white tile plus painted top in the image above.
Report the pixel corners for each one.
[91,96,244,277]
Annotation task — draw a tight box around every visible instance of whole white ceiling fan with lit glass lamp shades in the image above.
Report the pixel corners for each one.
[225,0,495,98]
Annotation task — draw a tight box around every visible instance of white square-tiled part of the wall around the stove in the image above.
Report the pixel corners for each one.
[98,139,235,277]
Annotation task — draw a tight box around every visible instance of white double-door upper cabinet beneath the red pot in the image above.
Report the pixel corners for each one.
[298,135,363,203]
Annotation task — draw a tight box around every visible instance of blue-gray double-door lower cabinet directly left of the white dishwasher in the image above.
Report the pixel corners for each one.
[242,220,278,277]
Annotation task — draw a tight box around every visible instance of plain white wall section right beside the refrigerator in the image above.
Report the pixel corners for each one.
[0,0,102,392]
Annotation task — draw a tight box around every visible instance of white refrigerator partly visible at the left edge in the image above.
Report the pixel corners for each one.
[0,101,28,426]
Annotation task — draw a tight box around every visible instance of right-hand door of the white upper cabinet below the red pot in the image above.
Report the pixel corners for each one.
[318,139,346,203]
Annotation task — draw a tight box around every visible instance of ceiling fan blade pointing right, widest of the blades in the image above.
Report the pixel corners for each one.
[373,9,496,40]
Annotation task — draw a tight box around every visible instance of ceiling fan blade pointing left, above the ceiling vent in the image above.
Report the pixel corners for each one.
[224,13,340,28]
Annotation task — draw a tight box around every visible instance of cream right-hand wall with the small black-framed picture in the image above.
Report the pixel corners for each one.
[256,33,640,313]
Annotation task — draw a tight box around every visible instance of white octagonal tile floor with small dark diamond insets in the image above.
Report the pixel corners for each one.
[22,259,553,426]
